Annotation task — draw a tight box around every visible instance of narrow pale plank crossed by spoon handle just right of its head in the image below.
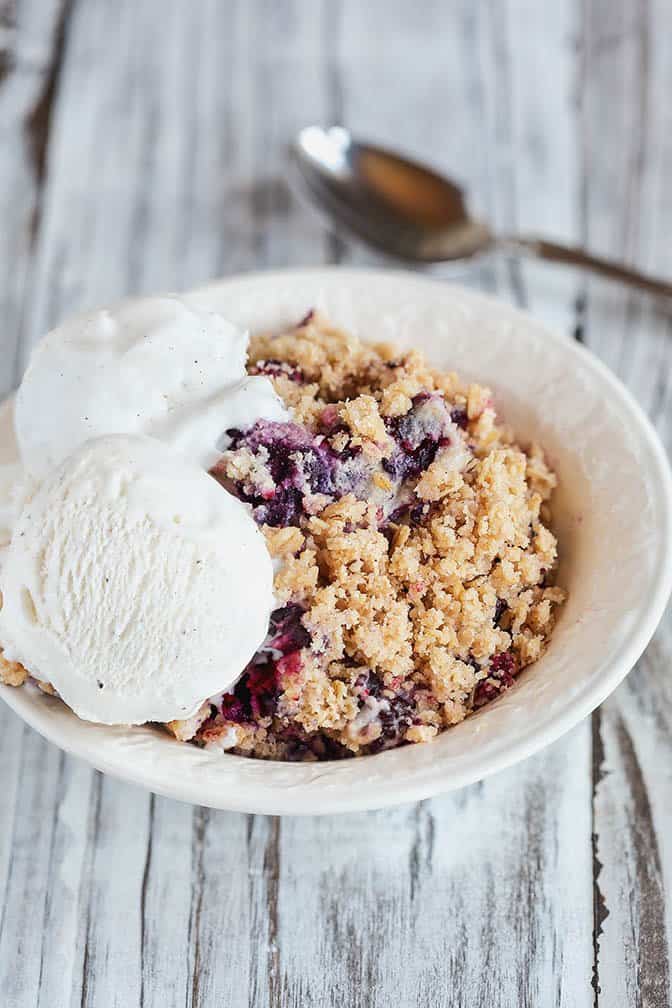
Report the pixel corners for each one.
[482,0,581,335]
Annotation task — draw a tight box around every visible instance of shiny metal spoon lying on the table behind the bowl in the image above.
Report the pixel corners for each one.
[293,126,672,297]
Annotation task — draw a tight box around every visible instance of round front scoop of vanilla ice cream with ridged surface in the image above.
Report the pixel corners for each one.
[0,435,273,724]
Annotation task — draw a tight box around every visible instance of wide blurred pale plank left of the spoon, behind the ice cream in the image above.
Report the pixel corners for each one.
[26,0,332,366]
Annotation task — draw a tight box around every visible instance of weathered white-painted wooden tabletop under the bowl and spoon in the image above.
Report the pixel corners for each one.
[0,0,672,1008]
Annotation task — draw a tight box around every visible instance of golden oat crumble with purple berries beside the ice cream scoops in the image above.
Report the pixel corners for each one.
[168,312,564,760]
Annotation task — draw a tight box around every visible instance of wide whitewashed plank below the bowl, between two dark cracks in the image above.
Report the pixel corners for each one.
[279,730,591,1008]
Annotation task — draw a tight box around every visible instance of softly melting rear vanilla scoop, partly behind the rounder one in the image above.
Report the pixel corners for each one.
[15,296,288,479]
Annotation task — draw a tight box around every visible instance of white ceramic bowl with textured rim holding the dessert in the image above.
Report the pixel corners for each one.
[0,268,672,814]
